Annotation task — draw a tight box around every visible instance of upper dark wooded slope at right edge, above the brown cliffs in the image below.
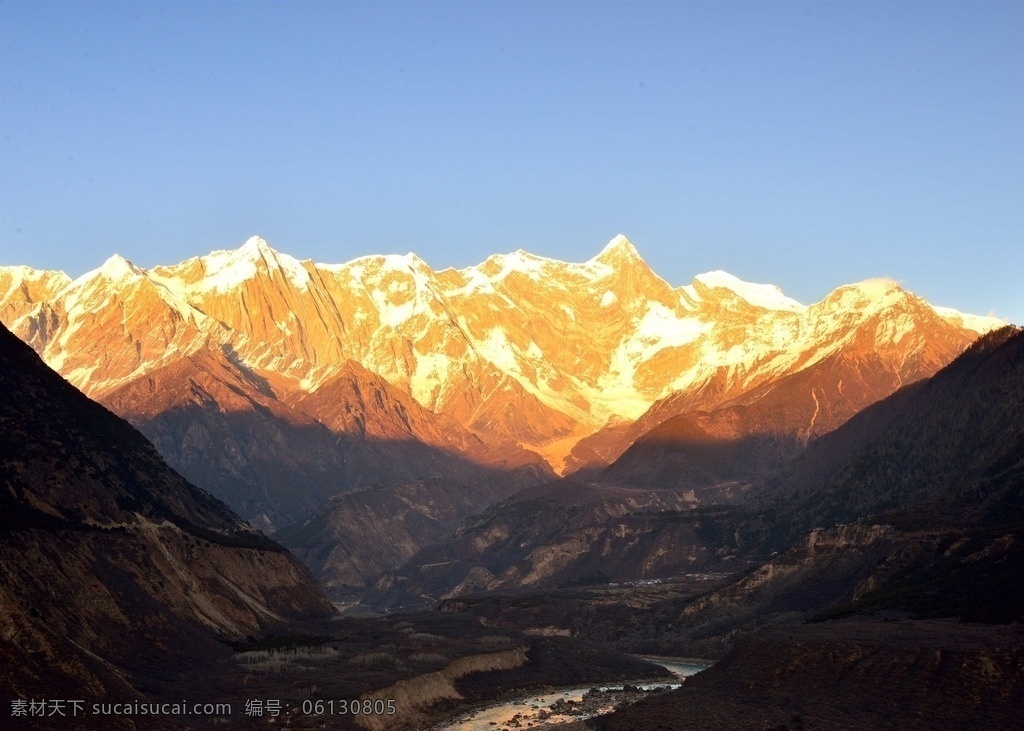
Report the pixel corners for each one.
[768,328,1024,531]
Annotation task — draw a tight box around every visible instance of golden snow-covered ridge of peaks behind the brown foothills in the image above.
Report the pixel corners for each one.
[0,235,1001,463]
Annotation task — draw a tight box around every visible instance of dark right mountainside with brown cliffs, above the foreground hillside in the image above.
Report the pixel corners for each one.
[647,328,1024,651]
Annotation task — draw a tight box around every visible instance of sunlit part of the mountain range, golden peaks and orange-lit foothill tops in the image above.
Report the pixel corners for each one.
[0,235,999,497]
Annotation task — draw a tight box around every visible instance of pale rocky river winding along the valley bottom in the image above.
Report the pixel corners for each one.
[434,657,711,731]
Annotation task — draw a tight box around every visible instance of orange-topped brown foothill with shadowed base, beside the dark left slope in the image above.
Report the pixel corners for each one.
[101,350,348,530]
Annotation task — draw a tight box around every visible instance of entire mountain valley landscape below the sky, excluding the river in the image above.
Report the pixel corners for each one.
[0,237,1024,731]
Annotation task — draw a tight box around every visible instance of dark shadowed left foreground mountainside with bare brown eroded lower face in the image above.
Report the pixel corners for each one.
[0,329,333,712]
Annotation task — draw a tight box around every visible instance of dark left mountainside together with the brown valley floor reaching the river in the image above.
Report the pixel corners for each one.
[0,319,668,731]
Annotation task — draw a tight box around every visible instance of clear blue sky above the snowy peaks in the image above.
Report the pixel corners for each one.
[0,2,1024,323]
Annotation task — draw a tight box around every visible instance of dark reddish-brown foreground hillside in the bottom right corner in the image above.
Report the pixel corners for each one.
[592,619,1024,731]
